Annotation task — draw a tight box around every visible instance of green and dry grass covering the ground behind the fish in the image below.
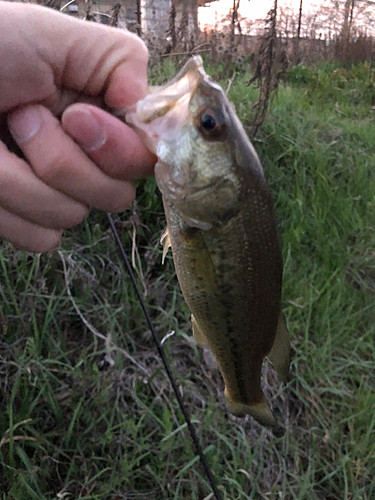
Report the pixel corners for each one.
[0,60,375,500]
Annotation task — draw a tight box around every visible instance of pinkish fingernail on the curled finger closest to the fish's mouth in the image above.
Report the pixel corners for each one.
[62,108,107,153]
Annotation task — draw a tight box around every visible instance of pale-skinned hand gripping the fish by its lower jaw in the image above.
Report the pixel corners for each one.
[0,2,155,252]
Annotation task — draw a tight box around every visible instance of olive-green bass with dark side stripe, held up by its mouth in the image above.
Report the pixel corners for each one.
[126,56,290,436]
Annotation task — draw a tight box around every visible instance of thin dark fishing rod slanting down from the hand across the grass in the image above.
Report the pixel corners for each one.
[107,213,222,500]
